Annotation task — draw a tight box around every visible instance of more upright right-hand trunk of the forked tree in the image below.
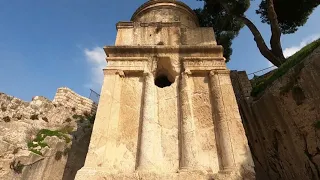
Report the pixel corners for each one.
[267,0,286,64]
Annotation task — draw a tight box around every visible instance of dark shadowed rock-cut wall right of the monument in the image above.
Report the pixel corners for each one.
[232,48,320,180]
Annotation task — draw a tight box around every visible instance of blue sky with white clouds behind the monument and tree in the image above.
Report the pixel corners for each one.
[0,0,320,101]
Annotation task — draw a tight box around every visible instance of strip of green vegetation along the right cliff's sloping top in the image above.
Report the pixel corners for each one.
[251,39,320,97]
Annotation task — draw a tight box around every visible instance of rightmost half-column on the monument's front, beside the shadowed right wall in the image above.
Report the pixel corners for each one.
[209,70,235,171]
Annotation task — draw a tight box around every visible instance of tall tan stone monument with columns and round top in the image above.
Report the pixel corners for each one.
[76,0,254,180]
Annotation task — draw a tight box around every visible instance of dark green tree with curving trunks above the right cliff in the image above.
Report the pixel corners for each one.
[195,0,320,66]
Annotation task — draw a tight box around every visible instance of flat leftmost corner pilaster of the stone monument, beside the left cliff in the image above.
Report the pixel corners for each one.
[80,69,124,171]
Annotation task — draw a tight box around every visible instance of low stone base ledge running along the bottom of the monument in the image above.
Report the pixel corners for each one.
[75,168,254,180]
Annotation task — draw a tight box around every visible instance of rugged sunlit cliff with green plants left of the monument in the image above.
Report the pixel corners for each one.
[0,88,96,180]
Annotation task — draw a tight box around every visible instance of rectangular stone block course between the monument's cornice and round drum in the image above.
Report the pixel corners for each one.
[115,22,217,46]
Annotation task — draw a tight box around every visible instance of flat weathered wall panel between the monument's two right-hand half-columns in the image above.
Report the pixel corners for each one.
[190,75,219,173]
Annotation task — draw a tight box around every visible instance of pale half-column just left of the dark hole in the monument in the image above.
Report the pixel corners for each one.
[137,72,162,171]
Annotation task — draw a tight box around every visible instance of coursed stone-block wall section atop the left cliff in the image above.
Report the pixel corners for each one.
[53,87,98,114]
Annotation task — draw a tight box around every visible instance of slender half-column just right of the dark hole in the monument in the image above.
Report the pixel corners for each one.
[179,71,198,171]
